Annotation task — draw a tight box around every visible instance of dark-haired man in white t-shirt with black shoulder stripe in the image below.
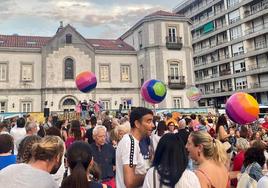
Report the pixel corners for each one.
[116,107,154,188]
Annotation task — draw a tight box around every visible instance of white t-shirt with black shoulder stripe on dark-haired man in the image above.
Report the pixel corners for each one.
[116,134,146,188]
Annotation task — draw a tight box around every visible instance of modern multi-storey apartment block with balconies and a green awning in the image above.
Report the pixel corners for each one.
[173,0,268,108]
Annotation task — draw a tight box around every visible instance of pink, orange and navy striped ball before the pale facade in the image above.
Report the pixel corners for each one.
[75,71,97,93]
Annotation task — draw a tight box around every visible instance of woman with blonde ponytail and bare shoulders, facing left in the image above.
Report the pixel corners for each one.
[186,131,230,188]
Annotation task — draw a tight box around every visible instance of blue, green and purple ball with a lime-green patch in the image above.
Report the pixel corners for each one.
[141,79,167,104]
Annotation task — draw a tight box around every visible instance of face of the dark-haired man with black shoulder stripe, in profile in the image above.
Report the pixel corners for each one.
[136,114,155,137]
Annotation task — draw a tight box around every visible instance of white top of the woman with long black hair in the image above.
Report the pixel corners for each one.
[143,168,201,188]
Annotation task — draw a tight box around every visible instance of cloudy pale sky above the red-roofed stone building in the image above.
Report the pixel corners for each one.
[0,0,181,39]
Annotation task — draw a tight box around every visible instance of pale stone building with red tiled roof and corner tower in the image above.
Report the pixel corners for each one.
[0,11,193,112]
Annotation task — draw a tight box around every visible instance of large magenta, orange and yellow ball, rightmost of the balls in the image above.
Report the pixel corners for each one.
[225,92,260,125]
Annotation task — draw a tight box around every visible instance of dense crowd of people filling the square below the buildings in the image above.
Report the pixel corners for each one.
[0,107,268,188]
